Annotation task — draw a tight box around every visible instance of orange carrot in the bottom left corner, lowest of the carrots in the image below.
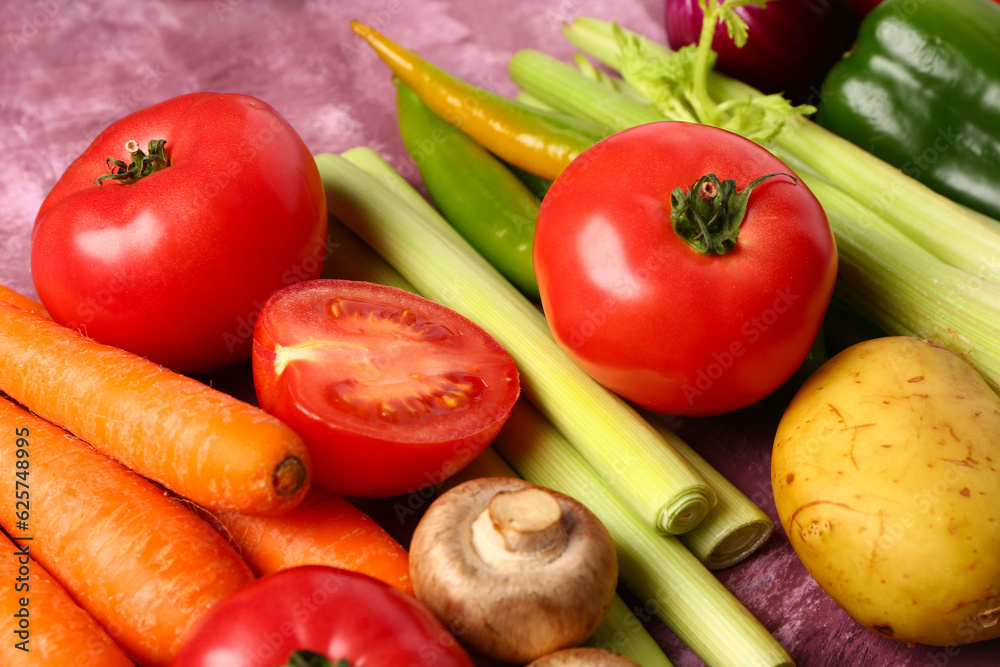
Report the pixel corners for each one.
[0,535,133,667]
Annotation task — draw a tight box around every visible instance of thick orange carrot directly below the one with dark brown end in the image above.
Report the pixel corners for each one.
[0,399,254,667]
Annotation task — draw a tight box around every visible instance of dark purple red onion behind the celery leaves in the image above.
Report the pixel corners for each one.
[665,0,859,104]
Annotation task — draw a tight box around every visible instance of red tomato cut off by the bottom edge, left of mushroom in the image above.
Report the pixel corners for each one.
[172,565,473,667]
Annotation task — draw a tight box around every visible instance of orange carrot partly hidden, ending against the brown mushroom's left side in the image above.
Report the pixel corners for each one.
[212,486,413,595]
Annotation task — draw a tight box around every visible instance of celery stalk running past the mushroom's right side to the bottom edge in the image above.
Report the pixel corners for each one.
[493,405,793,667]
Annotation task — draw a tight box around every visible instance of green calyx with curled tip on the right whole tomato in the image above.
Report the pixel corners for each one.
[670,172,798,255]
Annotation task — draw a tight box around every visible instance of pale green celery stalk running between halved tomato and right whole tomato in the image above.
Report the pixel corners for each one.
[316,149,716,534]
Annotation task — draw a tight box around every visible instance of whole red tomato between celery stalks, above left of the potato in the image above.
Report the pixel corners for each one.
[534,121,837,416]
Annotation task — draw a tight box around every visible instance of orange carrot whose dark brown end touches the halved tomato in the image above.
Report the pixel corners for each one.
[0,303,311,514]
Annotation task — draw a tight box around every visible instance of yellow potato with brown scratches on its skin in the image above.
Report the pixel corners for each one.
[771,336,1000,646]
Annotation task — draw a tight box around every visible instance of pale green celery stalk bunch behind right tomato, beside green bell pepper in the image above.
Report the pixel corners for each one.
[510,19,1000,388]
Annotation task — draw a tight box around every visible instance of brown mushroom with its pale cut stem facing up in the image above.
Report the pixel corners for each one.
[410,477,618,664]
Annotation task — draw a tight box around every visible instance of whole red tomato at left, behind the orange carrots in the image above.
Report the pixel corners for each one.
[31,93,327,373]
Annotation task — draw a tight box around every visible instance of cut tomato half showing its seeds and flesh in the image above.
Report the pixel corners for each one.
[253,279,520,497]
